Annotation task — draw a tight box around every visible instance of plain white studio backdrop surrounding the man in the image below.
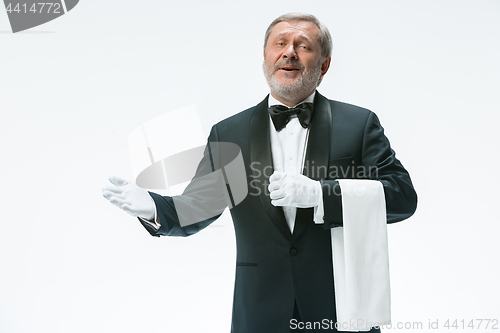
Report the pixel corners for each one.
[0,0,500,333]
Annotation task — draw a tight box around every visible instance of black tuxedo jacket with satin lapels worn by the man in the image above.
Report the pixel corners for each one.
[139,93,417,333]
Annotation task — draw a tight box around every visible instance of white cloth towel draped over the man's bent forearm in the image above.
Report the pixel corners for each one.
[331,179,391,332]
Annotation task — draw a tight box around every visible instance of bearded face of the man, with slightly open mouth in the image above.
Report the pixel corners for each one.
[263,21,330,99]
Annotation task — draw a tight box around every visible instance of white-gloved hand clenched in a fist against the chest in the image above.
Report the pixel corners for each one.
[268,171,322,208]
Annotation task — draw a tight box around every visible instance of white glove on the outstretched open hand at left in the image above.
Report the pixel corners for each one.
[102,176,156,221]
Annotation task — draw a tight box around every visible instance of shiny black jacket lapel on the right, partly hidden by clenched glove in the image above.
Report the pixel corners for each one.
[292,91,332,241]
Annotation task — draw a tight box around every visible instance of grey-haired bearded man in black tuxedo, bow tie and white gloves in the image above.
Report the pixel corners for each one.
[103,14,417,333]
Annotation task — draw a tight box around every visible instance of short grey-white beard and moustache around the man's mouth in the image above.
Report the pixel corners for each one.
[262,59,321,99]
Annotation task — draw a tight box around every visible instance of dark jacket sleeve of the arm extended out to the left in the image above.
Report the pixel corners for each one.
[139,126,227,237]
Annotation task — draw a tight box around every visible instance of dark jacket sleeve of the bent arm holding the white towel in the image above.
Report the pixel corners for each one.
[322,112,417,228]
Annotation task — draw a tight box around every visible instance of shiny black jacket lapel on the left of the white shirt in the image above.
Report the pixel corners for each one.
[250,96,292,240]
